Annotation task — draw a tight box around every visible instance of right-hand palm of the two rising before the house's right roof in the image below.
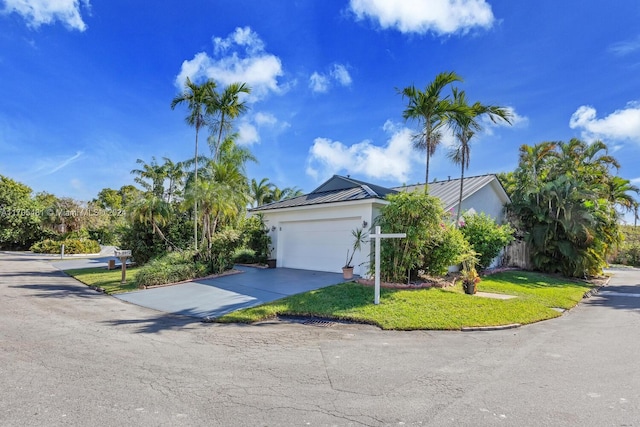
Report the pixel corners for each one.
[449,88,511,224]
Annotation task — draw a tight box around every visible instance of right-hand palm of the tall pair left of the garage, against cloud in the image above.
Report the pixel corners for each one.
[207,83,251,161]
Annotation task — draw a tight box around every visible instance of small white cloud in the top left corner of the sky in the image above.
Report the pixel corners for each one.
[3,0,91,31]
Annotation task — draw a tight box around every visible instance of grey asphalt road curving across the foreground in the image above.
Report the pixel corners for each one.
[0,254,640,426]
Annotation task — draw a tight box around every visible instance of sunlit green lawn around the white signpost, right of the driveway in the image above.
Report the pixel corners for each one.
[217,271,591,330]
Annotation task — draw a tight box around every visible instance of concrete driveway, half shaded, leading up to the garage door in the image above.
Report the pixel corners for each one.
[115,267,344,318]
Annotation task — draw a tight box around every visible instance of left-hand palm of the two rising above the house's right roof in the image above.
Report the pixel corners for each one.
[400,71,462,192]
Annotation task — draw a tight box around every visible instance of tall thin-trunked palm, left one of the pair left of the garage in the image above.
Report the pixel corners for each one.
[171,77,216,250]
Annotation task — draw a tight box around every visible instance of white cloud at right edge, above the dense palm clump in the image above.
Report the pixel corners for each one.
[569,102,640,142]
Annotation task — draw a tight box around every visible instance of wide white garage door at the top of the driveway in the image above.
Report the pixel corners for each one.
[278,217,362,273]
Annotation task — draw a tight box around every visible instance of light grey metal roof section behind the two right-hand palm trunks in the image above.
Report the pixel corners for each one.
[394,175,508,210]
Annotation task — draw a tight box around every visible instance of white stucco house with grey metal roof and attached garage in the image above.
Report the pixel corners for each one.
[249,175,509,275]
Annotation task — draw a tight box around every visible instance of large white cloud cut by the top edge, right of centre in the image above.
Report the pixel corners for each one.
[349,0,494,34]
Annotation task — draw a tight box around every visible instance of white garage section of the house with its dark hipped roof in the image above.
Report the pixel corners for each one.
[249,175,396,276]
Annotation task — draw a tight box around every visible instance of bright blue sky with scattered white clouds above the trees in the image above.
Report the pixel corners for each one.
[0,0,640,217]
